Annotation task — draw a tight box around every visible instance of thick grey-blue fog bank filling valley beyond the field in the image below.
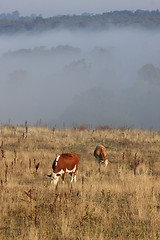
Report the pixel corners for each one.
[0,28,160,129]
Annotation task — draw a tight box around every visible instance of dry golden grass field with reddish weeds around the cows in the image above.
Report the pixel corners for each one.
[0,125,160,240]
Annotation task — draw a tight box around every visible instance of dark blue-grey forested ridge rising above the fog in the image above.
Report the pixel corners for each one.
[0,10,160,34]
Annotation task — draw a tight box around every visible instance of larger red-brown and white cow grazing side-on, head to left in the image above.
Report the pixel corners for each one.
[48,153,79,185]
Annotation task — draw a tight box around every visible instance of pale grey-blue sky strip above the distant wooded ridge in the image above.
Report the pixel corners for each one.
[0,0,160,17]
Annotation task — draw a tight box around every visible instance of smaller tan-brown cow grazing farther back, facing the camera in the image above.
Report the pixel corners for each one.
[94,145,108,166]
